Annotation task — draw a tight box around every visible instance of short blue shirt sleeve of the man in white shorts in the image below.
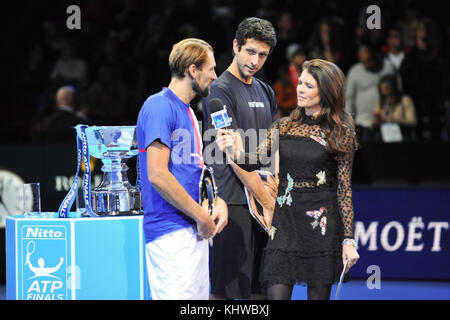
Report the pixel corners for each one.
[140,96,174,149]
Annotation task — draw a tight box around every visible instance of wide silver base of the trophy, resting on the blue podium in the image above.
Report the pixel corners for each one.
[91,189,143,217]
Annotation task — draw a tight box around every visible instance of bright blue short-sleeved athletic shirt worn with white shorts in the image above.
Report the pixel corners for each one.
[136,88,203,243]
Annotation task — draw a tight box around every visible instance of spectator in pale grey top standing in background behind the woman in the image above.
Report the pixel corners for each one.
[346,45,393,144]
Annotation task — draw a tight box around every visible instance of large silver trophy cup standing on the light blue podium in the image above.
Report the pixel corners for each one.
[86,126,142,216]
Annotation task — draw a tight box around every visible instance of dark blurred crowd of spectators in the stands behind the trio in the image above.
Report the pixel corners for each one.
[0,0,450,143]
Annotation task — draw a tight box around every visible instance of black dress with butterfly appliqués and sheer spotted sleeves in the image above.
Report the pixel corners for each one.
[246,116,355,285]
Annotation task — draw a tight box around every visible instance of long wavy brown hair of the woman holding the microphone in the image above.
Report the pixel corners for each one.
[290,59,356,153]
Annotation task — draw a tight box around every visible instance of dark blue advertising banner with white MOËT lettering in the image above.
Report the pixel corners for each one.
[352,188,450,280]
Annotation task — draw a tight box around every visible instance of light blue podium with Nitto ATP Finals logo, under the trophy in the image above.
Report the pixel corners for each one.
[6,216,150,300]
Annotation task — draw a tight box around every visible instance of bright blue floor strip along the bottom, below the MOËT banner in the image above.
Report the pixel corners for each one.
[0,280,450,300]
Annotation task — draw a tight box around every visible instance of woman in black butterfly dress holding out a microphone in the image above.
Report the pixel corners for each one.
[217,59,359,299]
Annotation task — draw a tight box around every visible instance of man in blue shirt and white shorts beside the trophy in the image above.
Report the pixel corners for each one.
[137,39,228,299]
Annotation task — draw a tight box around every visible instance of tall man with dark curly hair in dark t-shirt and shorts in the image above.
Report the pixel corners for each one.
[203,17,278,299]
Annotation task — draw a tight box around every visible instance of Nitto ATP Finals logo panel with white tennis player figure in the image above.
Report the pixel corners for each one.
[19,225,68,300]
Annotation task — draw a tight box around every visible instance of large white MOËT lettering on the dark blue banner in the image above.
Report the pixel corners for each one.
[355,217,449,252]
